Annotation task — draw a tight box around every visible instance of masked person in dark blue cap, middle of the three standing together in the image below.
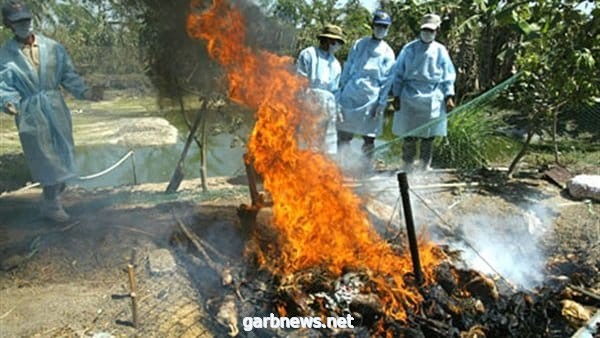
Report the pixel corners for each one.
[337,10,395,162]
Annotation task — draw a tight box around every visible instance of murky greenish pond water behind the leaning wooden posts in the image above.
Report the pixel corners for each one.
[75,104,251,188]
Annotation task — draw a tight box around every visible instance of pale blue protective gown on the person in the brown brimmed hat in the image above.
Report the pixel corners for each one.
[296,47,342,154]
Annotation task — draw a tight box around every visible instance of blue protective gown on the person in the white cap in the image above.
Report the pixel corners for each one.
[392,39,456,138]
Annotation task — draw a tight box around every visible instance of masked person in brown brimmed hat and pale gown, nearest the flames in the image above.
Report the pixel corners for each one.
[296,24,345,155]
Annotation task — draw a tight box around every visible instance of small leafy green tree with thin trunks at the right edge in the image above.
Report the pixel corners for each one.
[508,0,600,176]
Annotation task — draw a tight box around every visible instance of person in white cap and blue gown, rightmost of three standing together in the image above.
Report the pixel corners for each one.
[392,14,456,171]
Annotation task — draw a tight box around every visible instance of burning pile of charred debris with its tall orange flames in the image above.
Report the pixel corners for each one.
[187,0,600,337]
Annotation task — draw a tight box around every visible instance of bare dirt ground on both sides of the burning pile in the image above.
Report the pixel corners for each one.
[0,174,600,337]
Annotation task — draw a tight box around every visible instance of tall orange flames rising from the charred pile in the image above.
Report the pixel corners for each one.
[187,0,440,320]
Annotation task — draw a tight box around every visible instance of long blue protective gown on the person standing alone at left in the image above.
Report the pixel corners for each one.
[0,34,87,186]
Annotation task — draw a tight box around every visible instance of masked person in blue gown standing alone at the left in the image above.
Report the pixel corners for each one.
[0,0,100,222]
